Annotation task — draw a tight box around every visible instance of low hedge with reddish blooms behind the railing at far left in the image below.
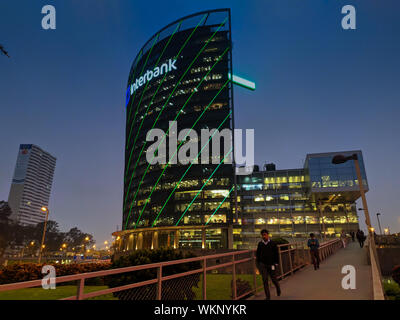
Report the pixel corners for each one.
[0,263,111,285]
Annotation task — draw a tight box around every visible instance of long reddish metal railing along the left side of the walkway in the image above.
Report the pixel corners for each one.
[0,239,343,300]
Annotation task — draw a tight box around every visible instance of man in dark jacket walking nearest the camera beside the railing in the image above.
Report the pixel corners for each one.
[256,229,281,300]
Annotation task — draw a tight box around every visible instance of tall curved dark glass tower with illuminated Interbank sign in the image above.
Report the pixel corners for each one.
[122,9,234,248]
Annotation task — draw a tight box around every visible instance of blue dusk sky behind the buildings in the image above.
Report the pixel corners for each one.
[0,0,400,243]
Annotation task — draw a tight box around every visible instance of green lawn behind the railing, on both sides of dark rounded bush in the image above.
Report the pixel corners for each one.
[0,274,262,300]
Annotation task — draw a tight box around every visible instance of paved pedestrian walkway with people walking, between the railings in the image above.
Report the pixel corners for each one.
[249,242,373,300]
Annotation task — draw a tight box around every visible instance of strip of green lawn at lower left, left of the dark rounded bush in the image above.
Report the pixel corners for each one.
[0,286,118,300]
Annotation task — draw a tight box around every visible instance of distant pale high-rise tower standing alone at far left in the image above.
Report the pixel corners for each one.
[8,144,56,225]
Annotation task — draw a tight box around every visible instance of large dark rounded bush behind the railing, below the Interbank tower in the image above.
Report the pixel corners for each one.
[105,248,201,300]
